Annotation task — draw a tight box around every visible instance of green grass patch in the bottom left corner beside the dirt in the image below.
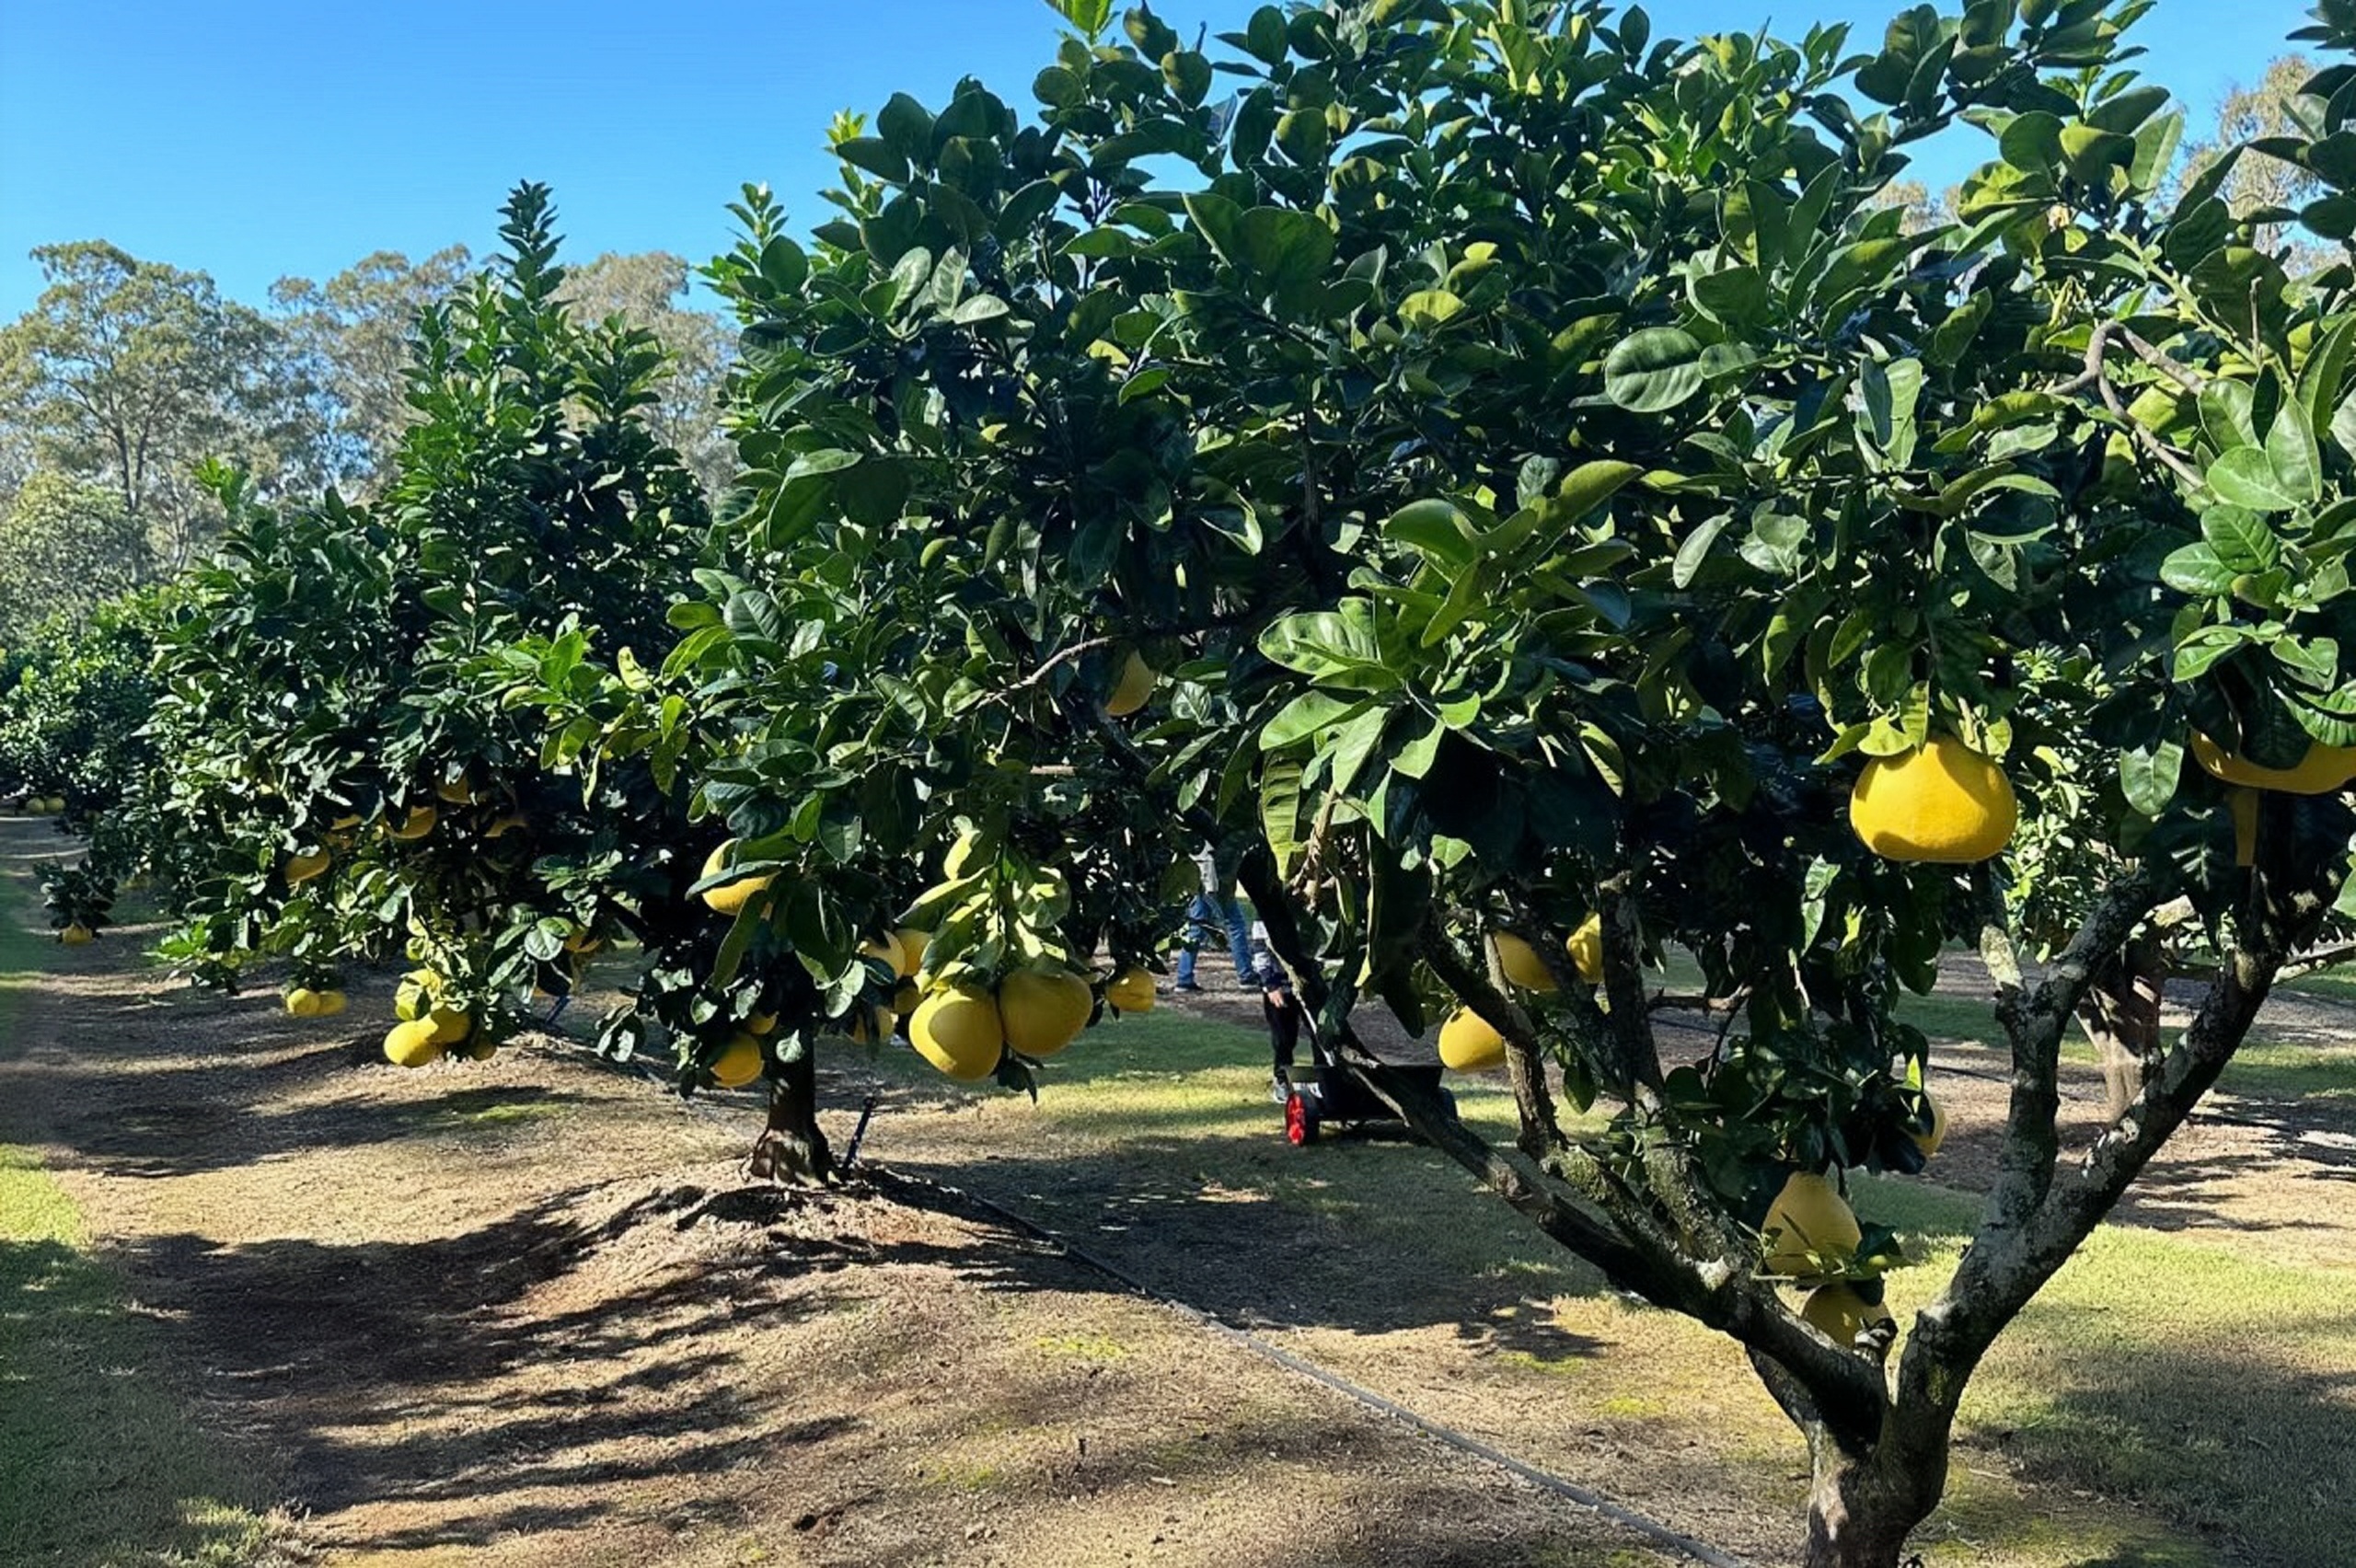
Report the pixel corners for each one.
[0,824,285,1568]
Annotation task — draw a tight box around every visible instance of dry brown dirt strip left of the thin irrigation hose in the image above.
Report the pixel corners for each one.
[0,824,1696,1568]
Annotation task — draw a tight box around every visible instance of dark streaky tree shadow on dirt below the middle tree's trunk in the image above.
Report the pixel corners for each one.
[96,1168,1105,1547]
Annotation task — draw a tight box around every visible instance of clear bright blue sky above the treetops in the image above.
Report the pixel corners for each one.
[0,0,2306,320]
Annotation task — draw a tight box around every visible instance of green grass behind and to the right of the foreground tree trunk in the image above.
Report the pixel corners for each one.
[886,998,2356,1568]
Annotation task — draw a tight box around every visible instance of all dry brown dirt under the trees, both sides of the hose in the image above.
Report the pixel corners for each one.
[0,805,2356,1568]
